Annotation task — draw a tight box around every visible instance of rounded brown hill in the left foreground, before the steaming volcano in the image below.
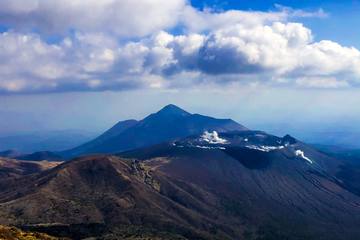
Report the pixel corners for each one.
[0,156,226,239]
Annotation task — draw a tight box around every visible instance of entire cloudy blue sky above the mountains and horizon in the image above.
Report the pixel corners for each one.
[0,0,360,135]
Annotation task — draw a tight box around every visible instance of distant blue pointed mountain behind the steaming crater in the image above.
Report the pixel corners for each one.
[61,104,247,157]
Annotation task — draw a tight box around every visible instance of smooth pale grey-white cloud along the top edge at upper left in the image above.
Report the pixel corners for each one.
[0,0,186,37]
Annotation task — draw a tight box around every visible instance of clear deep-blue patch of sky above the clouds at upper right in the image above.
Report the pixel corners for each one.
[191,0,360,48]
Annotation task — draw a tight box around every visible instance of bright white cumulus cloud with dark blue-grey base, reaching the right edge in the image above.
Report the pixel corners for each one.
[194,22,360,78]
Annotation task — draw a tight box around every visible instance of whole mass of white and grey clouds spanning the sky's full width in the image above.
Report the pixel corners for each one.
[0,0,360,93]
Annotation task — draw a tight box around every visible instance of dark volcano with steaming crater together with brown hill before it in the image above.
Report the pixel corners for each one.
[0,131,360,240]
